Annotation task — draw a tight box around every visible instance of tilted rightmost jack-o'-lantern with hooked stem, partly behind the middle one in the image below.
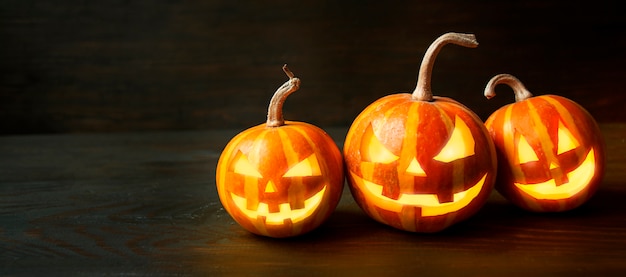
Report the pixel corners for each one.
[485,74,605,212]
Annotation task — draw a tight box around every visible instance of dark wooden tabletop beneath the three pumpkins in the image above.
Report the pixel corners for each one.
[0,124,626,276]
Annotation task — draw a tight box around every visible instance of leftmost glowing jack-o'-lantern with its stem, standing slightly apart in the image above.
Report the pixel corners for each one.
[216,66,344,237]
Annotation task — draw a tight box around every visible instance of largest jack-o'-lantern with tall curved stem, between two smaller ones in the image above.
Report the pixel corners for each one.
[344,33,497,232]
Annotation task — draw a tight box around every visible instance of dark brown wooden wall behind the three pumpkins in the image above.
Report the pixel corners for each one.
[0,0,626,135]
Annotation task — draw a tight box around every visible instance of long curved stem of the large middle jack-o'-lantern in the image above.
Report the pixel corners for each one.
[413,33,478,101]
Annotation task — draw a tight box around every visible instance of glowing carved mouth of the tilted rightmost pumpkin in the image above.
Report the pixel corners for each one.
[514,149,596,200]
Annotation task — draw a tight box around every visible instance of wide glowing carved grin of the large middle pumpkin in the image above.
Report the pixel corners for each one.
[350,173,487,216]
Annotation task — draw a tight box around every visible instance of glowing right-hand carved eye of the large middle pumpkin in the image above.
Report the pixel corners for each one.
[433,116,475,163]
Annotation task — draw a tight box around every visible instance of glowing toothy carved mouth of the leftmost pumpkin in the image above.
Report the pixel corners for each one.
[230,186,326,225]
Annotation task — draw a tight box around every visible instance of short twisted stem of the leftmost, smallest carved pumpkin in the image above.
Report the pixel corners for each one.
[267,64,300,127]
